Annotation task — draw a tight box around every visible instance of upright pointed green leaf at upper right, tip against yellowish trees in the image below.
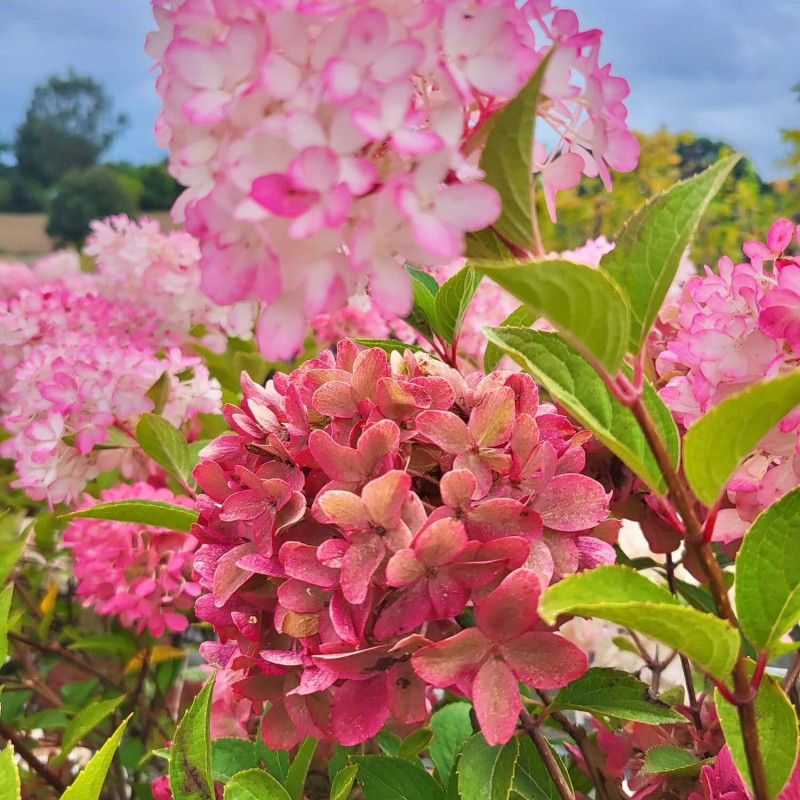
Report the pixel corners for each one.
[600,155,741,353]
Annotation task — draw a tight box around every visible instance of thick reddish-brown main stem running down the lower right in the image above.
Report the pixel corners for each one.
[630,396,770,800]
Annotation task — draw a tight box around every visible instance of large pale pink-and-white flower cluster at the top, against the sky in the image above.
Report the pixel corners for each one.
[147,0,638,359]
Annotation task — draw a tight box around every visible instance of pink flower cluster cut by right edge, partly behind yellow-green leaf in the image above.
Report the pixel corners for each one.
[653,220,800,542]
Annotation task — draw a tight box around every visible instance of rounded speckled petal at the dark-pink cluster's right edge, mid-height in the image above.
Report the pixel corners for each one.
[533,475,609,531]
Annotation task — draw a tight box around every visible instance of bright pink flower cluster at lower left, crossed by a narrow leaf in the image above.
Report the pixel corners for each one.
[63,483,201,638]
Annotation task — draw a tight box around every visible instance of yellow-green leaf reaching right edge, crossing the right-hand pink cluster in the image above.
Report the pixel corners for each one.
[683,370,800,506]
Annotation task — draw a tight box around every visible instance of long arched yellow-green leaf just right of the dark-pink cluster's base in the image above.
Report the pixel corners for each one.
[539,565,739,681]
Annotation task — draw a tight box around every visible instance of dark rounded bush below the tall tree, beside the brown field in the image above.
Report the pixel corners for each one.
[47,166,136,246]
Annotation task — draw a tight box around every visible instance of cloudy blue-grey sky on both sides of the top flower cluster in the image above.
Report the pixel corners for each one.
[0,0,800,179]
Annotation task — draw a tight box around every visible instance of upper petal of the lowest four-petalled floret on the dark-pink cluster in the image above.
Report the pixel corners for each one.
[475,569,540,642]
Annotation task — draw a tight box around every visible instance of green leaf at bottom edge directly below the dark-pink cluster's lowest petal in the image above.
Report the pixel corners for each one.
[458,733,519,800]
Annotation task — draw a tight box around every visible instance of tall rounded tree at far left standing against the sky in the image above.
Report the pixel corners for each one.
[13,69,127,187]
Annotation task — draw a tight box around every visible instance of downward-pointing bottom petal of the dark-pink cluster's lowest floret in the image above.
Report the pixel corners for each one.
[472,657,522,745]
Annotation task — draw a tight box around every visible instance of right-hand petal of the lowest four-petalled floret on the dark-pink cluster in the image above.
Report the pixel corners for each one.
[501,631,587,689]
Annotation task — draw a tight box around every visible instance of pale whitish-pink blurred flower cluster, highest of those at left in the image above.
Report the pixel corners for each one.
[84,215,256,352]
